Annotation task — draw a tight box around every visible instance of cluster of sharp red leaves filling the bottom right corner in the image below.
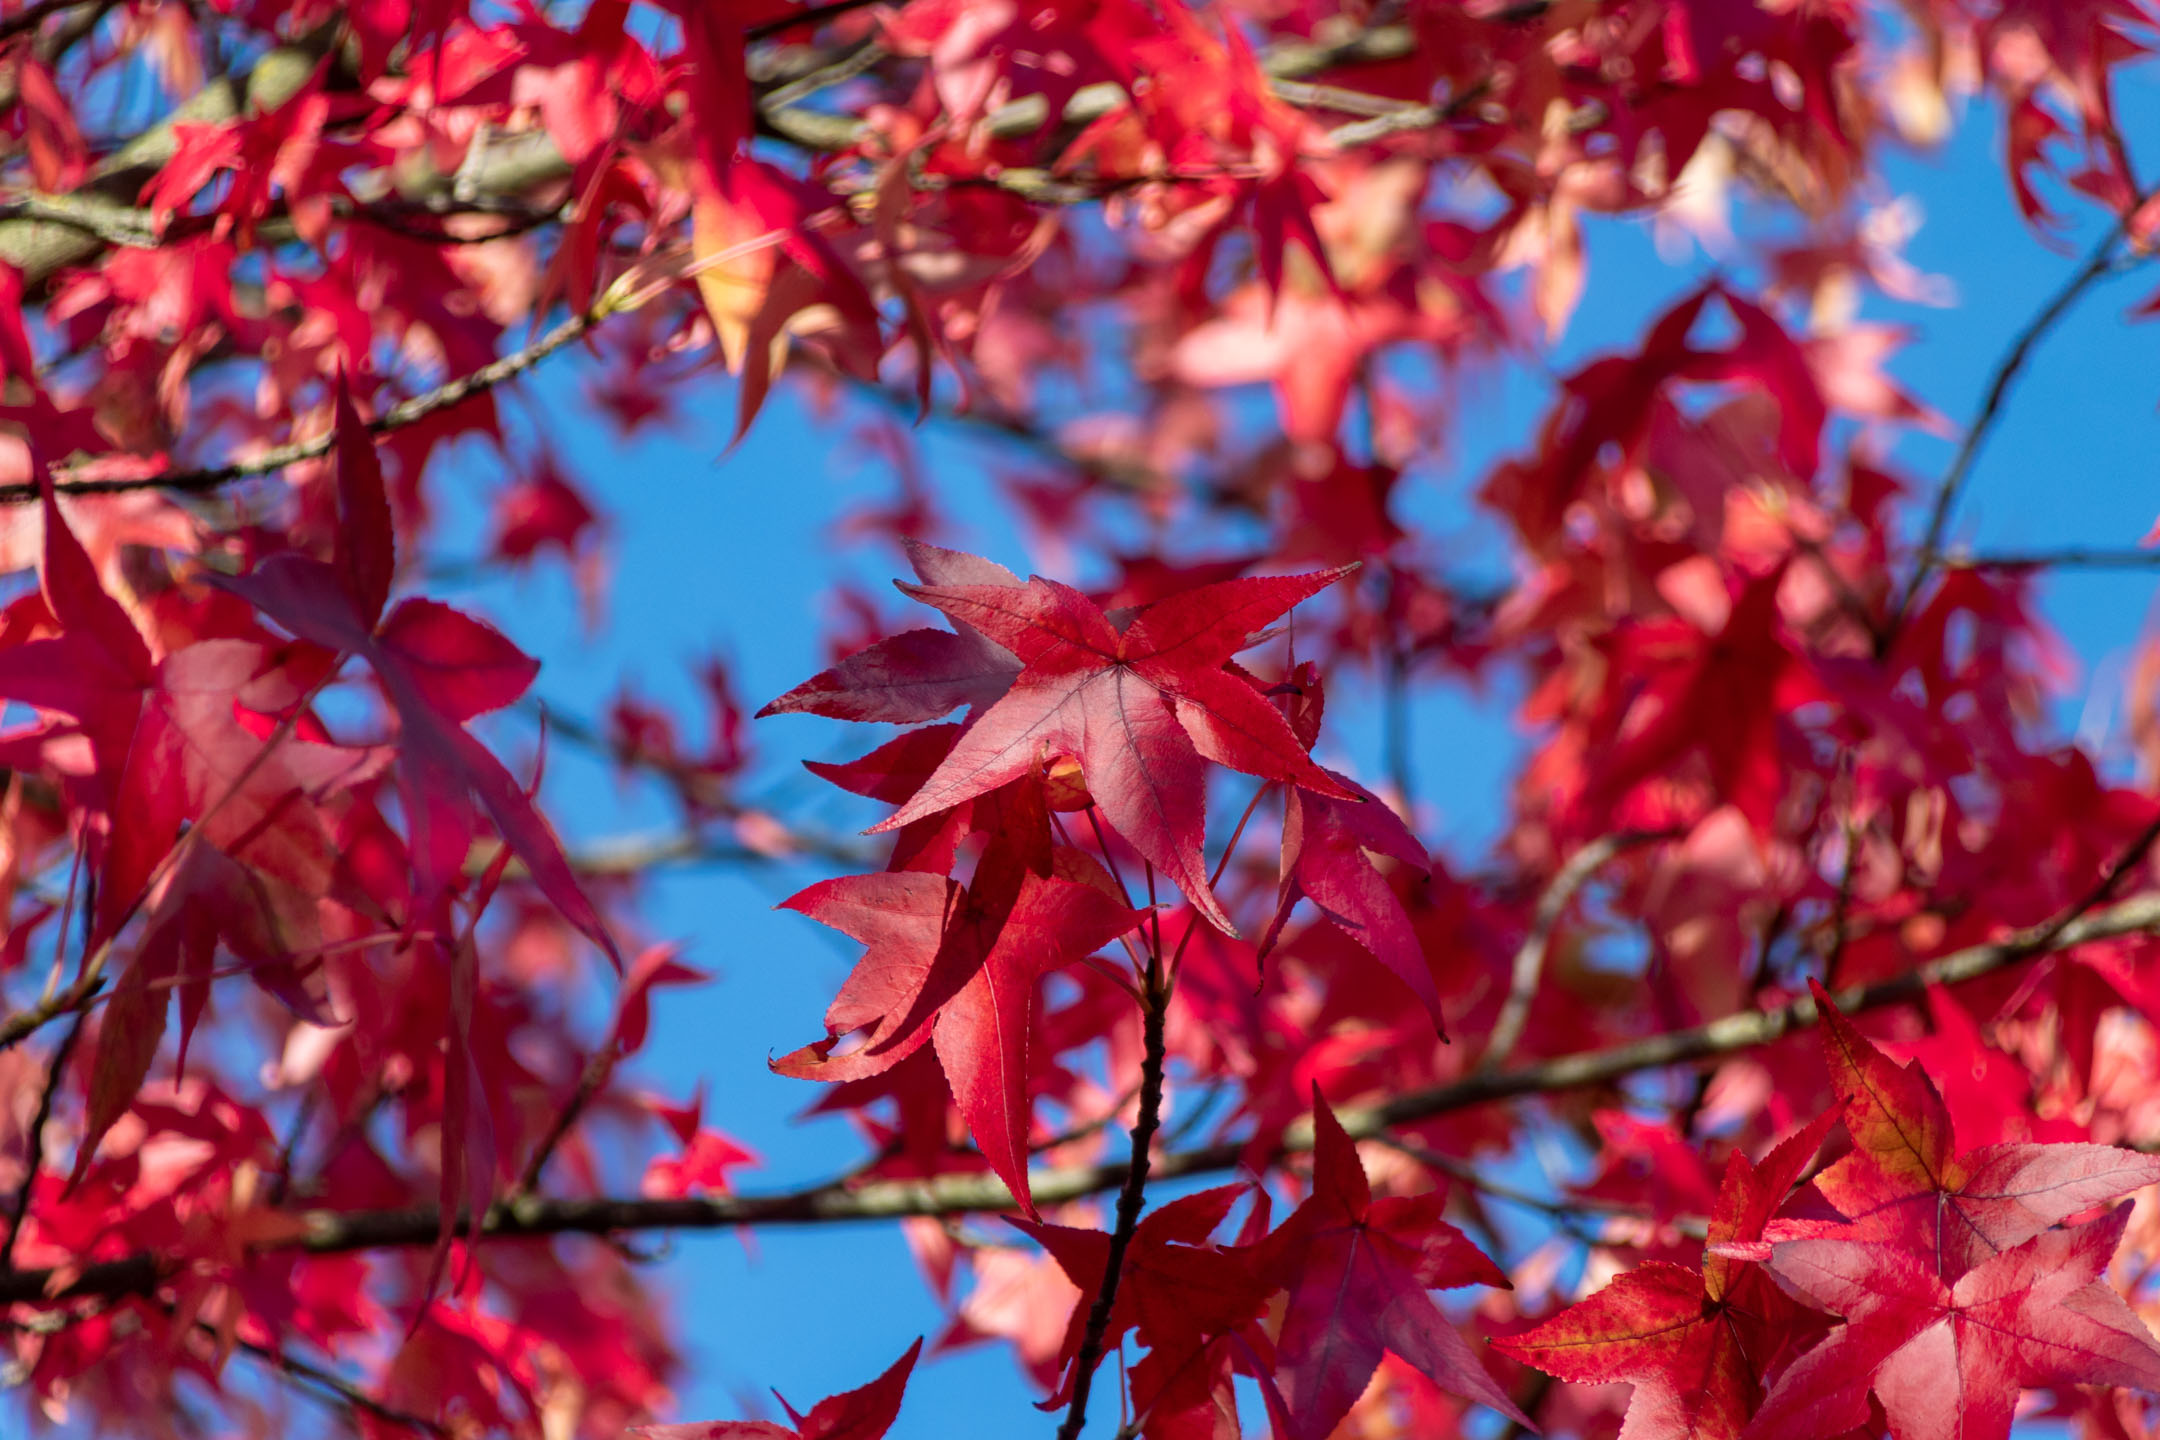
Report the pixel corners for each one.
[1499,987,2160,1440]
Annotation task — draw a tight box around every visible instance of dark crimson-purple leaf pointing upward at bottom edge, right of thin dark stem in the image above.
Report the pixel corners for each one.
[1261,1088,1529,1440]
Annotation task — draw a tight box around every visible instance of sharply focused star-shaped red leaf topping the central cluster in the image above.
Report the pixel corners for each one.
[873,568,1354,933]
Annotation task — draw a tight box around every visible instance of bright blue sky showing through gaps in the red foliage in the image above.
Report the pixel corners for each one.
[436,73,2160,1440]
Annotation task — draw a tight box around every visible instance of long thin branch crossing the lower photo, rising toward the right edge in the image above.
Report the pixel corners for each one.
[0,885,2160,1304]
